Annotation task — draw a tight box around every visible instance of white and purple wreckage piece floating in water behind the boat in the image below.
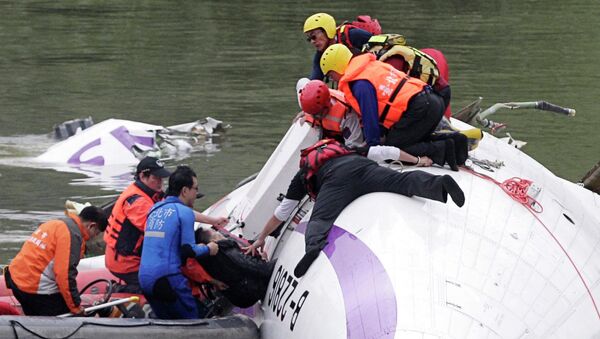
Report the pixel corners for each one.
[35,117,224,166]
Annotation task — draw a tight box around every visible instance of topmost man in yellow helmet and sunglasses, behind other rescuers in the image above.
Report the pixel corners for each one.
[304,13,372,80]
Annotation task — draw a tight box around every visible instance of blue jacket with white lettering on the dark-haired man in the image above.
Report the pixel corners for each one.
[139,196,209,287]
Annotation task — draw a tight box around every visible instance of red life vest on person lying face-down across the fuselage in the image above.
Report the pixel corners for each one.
[300,139,354,199]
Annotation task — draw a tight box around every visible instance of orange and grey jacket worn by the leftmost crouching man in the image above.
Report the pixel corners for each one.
[9,214,89,312]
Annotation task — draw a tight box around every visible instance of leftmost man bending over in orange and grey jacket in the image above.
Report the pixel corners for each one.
[4,206,107,316]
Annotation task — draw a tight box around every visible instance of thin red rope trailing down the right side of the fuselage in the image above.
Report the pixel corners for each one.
[461,167,600,319]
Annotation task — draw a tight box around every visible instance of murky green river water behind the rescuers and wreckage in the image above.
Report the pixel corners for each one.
[0,0,600,263]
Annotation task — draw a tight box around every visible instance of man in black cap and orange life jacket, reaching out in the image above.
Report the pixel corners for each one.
[104,157,227,293]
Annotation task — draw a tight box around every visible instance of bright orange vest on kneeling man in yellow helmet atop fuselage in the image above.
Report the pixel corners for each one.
[339,53,427,129]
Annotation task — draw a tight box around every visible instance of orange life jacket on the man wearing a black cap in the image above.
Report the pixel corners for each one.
[104,182,162,256]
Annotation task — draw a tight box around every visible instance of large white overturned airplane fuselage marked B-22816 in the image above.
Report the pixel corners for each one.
[207,121,600,339]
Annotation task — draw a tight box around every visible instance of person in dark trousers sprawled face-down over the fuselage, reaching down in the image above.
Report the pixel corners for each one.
[244,139,465,277]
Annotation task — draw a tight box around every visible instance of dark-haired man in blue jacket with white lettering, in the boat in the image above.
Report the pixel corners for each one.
[139,166,219,319]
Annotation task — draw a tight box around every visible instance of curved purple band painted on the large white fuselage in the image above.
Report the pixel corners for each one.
[296,223,397,339]
